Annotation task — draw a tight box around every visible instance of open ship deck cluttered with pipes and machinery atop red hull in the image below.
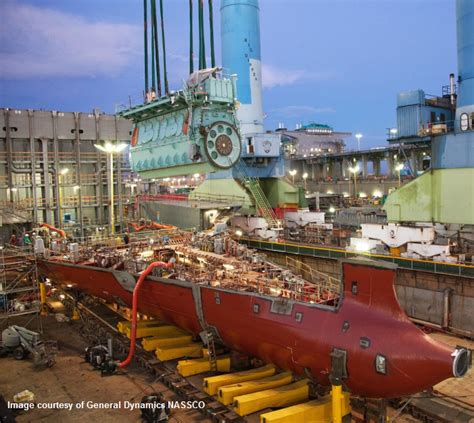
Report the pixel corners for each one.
[47,232,342,306]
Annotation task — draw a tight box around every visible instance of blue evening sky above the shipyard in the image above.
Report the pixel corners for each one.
[0,0,457,148]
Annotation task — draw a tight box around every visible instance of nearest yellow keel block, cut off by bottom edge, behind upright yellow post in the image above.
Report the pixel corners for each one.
[260,392,351,423]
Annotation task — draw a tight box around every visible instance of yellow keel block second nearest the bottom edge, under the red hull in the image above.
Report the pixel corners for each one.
[234,379,309,416]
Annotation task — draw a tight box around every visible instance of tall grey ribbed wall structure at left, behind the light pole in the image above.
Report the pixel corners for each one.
[0,109,134,237]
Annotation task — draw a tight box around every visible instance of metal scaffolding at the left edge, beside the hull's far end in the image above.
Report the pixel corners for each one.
[0,247,41,323]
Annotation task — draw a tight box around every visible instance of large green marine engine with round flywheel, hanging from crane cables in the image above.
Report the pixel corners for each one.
[118,68,242,178]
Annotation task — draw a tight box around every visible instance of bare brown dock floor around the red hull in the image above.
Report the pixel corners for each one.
[0,316,474,423]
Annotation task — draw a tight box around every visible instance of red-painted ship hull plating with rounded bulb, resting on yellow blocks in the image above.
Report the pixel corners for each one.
[40,261,464,398]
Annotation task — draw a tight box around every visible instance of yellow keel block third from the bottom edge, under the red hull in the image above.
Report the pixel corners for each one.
[217,372,293,405]
